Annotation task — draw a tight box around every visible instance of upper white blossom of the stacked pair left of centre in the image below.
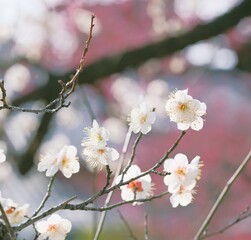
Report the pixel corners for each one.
[81,120,110,147]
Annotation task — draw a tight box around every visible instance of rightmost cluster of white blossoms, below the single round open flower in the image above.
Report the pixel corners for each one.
[164,153,202,208]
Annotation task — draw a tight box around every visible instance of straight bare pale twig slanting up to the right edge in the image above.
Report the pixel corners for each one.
[194,150,251,240]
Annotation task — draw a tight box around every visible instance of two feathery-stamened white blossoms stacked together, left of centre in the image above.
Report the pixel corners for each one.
[81,120,119,170]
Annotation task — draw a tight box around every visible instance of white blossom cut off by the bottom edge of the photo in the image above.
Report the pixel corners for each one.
[35,214,72,240]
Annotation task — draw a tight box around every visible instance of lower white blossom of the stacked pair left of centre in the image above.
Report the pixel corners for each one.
[83,146,119,170]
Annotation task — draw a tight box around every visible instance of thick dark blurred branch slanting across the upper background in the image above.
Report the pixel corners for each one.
[13,0,251,105]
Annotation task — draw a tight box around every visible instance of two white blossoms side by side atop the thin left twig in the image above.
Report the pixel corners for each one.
[38,145,80,178]
